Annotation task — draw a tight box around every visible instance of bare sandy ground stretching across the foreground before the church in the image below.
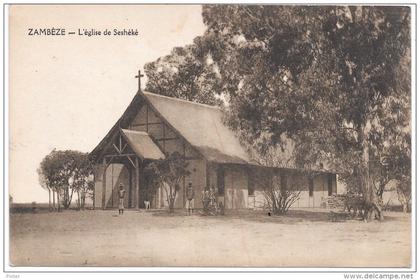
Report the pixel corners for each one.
[10,210,411,267]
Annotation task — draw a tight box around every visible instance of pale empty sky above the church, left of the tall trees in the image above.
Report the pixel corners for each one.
[8,5,205,202]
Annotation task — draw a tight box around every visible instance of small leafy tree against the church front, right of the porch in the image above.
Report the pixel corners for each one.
[147,152,190,213]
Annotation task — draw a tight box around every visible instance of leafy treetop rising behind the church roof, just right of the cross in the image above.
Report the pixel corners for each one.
[144,45,222,105]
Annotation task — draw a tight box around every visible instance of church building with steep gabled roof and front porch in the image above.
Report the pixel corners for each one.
[90,77,337,209]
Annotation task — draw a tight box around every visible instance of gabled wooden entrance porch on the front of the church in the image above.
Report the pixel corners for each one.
[94,129,165,209]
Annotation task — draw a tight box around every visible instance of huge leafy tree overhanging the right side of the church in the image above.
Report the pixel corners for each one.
[200,5,410,219]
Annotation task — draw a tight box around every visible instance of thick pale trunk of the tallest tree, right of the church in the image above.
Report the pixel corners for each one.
[358,124,383,221]
